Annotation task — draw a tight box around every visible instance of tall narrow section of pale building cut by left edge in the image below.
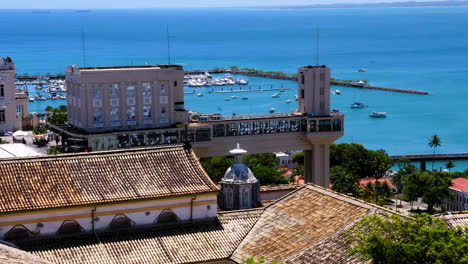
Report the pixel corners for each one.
[0,57,17,134]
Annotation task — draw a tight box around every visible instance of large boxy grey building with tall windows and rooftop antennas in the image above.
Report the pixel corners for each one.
[66,65,188,133]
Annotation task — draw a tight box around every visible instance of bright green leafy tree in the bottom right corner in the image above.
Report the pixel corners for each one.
[348,214,468,264]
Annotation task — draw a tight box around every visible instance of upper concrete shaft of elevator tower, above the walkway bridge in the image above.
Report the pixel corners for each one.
[297,65,330,116]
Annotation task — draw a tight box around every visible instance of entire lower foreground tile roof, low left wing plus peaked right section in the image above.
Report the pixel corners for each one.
[18,184,393,264]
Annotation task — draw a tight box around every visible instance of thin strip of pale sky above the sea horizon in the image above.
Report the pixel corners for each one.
[0,0,446,9]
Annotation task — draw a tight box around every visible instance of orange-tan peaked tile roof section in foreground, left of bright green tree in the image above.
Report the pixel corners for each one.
[232,185,391,263]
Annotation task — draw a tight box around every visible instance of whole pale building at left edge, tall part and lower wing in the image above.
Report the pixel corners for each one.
[0,57,30,135]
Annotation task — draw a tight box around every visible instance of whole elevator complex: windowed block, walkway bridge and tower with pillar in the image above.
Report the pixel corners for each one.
[51,65,344,188]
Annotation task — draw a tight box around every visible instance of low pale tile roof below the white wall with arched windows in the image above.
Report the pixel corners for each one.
[17,208,263,264]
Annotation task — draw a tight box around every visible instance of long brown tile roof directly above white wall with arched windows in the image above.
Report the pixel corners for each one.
[0,146,218,213]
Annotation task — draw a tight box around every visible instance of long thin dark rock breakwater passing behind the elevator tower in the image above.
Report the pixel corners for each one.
[185,69,429,95]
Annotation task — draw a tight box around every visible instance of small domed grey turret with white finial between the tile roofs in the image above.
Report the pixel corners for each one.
[218,143,261,210]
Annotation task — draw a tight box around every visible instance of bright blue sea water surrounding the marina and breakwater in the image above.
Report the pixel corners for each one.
[0,7,468,158]
